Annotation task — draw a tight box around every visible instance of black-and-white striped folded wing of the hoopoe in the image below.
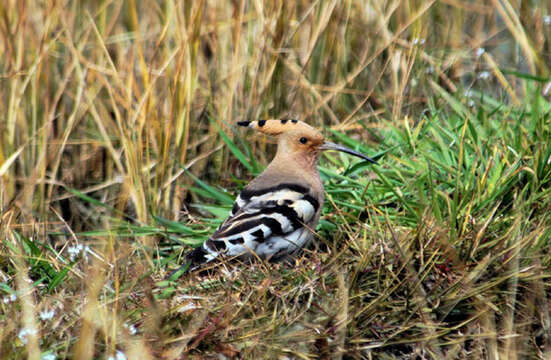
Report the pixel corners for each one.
[199,184,319,261]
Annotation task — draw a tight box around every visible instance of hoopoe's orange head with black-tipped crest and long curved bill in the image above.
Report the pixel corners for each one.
[237,119,377,164]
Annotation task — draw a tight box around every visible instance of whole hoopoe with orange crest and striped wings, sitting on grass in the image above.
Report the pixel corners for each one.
[173,119,376,274]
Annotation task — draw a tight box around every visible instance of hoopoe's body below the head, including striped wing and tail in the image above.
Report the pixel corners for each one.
[187,163,323,269]
